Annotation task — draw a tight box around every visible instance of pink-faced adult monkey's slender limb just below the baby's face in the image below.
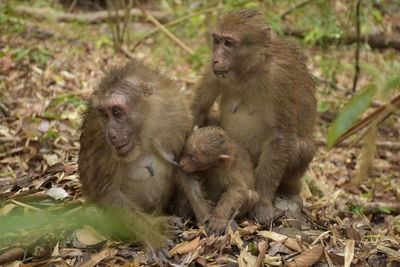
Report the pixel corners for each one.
[177,170,214,223]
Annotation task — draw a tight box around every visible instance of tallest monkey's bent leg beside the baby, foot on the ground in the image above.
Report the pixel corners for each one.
[253,135,293,224]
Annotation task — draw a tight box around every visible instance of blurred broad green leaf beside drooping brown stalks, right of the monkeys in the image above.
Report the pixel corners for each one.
[327,85,376,148]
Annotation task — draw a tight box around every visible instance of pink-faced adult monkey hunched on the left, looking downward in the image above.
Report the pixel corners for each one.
[78,59,193,248]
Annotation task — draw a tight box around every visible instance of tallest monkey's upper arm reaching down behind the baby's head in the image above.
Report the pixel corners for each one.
[191,72,220,126]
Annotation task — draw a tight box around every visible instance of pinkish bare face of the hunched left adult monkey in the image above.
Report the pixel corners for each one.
[95,92,140,158]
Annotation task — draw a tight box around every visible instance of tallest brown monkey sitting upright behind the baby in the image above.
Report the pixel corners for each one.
[192,10,316,223]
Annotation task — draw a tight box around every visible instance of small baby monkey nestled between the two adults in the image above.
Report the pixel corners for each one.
[179,126,258,235]
